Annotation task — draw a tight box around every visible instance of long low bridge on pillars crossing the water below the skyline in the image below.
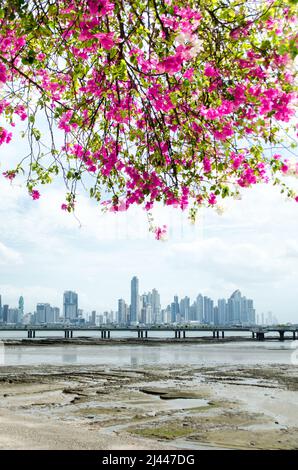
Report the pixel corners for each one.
[0,324,298,341]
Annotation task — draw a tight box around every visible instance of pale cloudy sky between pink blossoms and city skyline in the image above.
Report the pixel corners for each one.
[0,120,298,323]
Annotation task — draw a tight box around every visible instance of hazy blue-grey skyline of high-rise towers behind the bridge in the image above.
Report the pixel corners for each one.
[0,276,278,325]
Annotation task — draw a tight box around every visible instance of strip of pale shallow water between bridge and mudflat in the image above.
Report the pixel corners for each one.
[0,341,298,367]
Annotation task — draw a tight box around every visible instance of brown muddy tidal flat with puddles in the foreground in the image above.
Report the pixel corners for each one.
[0,354,298,450]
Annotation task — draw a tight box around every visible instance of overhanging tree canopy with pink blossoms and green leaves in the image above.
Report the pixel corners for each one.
[0,0,298,234]
